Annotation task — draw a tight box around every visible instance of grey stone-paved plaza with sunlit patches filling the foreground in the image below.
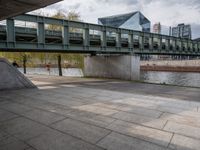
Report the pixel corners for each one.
[0,76,200,150]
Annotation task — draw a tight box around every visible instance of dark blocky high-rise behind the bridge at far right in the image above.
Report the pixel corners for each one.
[172,23,192,39]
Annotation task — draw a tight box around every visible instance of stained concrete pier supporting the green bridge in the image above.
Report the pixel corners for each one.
[84,55,140,80]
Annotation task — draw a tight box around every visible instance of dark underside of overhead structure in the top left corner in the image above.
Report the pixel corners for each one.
[0,0,61,20]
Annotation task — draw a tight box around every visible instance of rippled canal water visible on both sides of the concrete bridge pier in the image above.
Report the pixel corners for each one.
[19,68,200,87]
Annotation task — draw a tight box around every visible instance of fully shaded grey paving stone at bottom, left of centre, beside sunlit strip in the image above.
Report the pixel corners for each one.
[52,119,110,143]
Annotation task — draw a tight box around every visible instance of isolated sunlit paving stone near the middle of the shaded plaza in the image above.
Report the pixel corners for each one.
[73,104,118,116]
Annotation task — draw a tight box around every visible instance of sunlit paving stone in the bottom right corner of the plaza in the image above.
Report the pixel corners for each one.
[169,134,200,150]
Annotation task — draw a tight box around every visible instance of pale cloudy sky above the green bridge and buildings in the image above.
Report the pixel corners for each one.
[32,0,200,38]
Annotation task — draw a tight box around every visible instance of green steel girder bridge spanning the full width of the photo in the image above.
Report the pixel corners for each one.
[0,14,200,56]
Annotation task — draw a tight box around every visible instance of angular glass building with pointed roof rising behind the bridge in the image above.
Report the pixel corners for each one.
[98,11,151,32]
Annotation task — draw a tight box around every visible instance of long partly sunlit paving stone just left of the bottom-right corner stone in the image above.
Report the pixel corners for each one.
[108,120,172,147]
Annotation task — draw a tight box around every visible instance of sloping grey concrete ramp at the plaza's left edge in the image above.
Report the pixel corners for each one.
[0,58,36,90]
